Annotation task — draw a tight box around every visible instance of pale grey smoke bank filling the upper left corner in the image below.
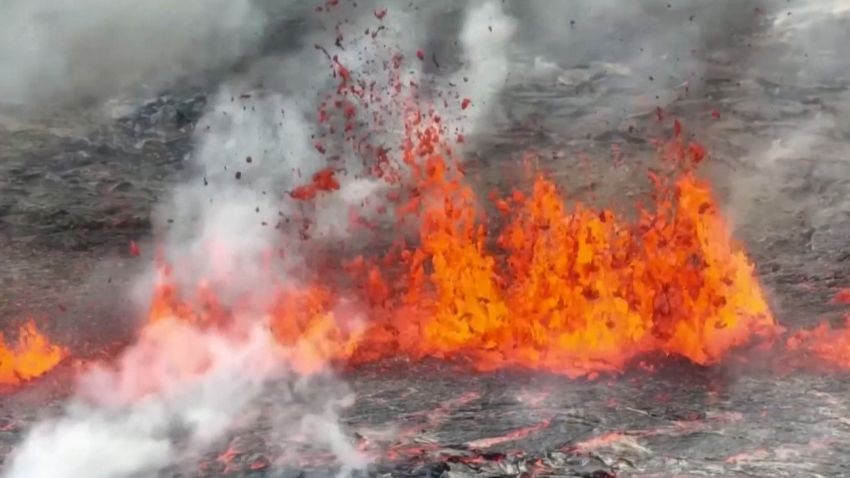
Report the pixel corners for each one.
[0,0,265,106]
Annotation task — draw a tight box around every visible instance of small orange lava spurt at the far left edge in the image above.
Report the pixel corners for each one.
[0,321,67,385]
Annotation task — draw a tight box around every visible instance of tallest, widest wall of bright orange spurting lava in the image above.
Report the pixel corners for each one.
[372,116,774,376]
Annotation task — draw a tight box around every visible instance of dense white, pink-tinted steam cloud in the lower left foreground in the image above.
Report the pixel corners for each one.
[6,322,284,478]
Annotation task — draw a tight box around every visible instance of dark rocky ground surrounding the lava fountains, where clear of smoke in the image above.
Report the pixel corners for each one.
[0,1,850,478]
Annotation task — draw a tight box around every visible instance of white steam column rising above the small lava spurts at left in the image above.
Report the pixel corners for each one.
[149,87,321,302]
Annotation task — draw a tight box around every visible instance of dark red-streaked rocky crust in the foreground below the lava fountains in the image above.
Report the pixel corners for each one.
[0,360,850,478]
